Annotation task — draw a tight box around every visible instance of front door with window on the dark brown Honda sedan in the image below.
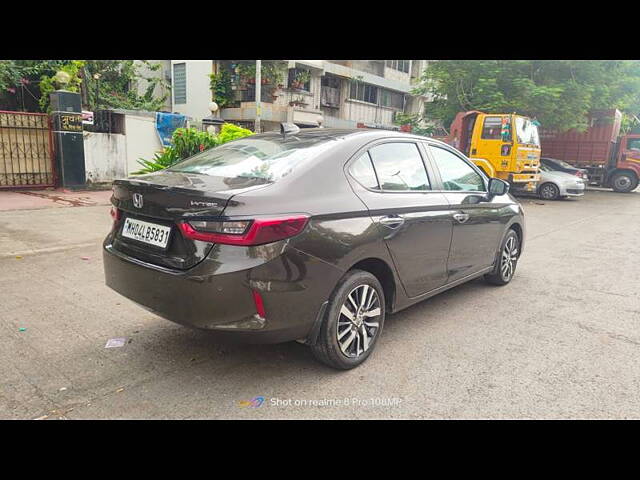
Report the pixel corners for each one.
[429,144,508,282]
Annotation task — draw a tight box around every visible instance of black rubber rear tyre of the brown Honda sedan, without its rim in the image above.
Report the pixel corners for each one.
[314,270,386,370]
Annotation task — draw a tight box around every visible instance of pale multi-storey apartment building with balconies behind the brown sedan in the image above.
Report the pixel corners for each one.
[171,60,427,131]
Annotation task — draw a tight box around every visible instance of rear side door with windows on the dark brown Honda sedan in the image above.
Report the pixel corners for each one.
[349,140,452,297]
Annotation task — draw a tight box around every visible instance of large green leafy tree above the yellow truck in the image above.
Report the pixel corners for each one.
[414,60,640,131]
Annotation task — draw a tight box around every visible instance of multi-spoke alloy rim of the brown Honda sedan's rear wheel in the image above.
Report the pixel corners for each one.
[336,284,382,358]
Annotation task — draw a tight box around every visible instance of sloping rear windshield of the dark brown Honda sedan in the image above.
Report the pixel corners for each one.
[169,135,335,185]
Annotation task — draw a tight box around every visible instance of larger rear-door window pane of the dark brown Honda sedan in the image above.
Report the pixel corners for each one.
[369,143,431,191]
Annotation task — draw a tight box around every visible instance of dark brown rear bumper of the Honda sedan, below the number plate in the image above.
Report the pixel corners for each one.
[103,237,342,343]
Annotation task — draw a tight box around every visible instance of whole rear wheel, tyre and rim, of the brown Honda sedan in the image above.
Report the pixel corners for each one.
[311,270,385,370]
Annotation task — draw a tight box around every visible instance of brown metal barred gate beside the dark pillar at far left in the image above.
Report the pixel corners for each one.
[0,110,56,189]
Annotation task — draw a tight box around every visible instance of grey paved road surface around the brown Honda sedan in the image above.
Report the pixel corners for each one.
[0,191,640,419]
